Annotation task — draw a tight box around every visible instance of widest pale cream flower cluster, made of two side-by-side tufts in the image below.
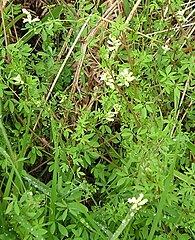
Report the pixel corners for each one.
[101,68,135,89]
